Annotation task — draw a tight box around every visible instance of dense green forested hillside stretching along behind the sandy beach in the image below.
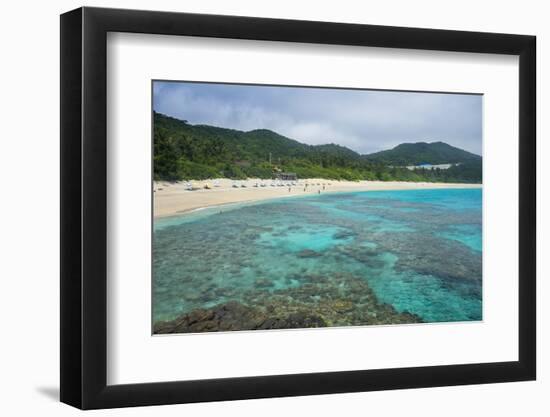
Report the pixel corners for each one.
[153,112,481,182]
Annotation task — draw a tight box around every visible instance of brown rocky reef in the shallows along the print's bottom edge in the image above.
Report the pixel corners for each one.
[154,274,421,334]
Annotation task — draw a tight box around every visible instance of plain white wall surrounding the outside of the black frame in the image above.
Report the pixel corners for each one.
[0,0,550,417]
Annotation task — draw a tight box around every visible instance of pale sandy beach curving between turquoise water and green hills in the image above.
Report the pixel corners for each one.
[153,178,481,218]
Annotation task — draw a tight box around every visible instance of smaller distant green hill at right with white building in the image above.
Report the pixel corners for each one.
[364,142,481,166]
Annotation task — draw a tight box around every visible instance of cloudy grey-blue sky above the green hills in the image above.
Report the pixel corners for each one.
[153,81,482,155]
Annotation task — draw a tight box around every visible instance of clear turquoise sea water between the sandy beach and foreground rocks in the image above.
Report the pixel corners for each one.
[153,189,482,324]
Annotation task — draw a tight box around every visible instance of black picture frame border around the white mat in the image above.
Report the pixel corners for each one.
[60,7,536,409]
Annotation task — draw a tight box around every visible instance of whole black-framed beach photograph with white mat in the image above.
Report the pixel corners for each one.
[61,7,536,409]
